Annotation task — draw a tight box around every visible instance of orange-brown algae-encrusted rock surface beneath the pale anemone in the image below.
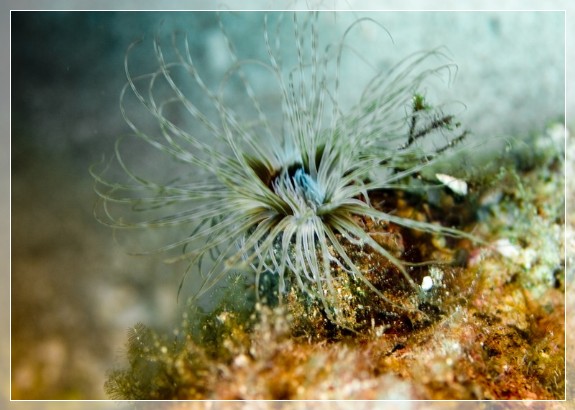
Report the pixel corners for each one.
[106,125,573,400]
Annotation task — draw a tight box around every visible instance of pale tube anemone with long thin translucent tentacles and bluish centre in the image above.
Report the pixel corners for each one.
[93,13,482,323]
